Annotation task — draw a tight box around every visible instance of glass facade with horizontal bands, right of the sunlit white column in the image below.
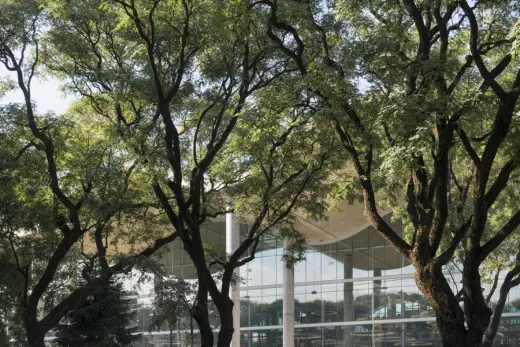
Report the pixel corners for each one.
[234,223,520,347]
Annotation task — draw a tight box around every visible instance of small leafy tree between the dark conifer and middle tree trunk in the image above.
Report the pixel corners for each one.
[152,280,194,347]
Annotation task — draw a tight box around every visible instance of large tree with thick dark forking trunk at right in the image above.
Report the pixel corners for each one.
[256,0,520,346]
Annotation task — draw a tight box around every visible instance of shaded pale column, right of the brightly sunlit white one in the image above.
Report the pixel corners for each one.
[283,239,294,347]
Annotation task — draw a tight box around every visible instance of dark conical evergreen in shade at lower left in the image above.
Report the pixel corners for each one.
[56,280,139,347]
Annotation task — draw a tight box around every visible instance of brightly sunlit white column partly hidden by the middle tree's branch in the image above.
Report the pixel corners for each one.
[226,200,240,347]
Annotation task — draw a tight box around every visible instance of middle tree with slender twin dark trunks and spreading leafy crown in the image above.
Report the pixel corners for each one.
[36,0,334,346]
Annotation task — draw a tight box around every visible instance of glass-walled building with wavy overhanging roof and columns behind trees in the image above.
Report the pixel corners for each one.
[130,206,520,347]
